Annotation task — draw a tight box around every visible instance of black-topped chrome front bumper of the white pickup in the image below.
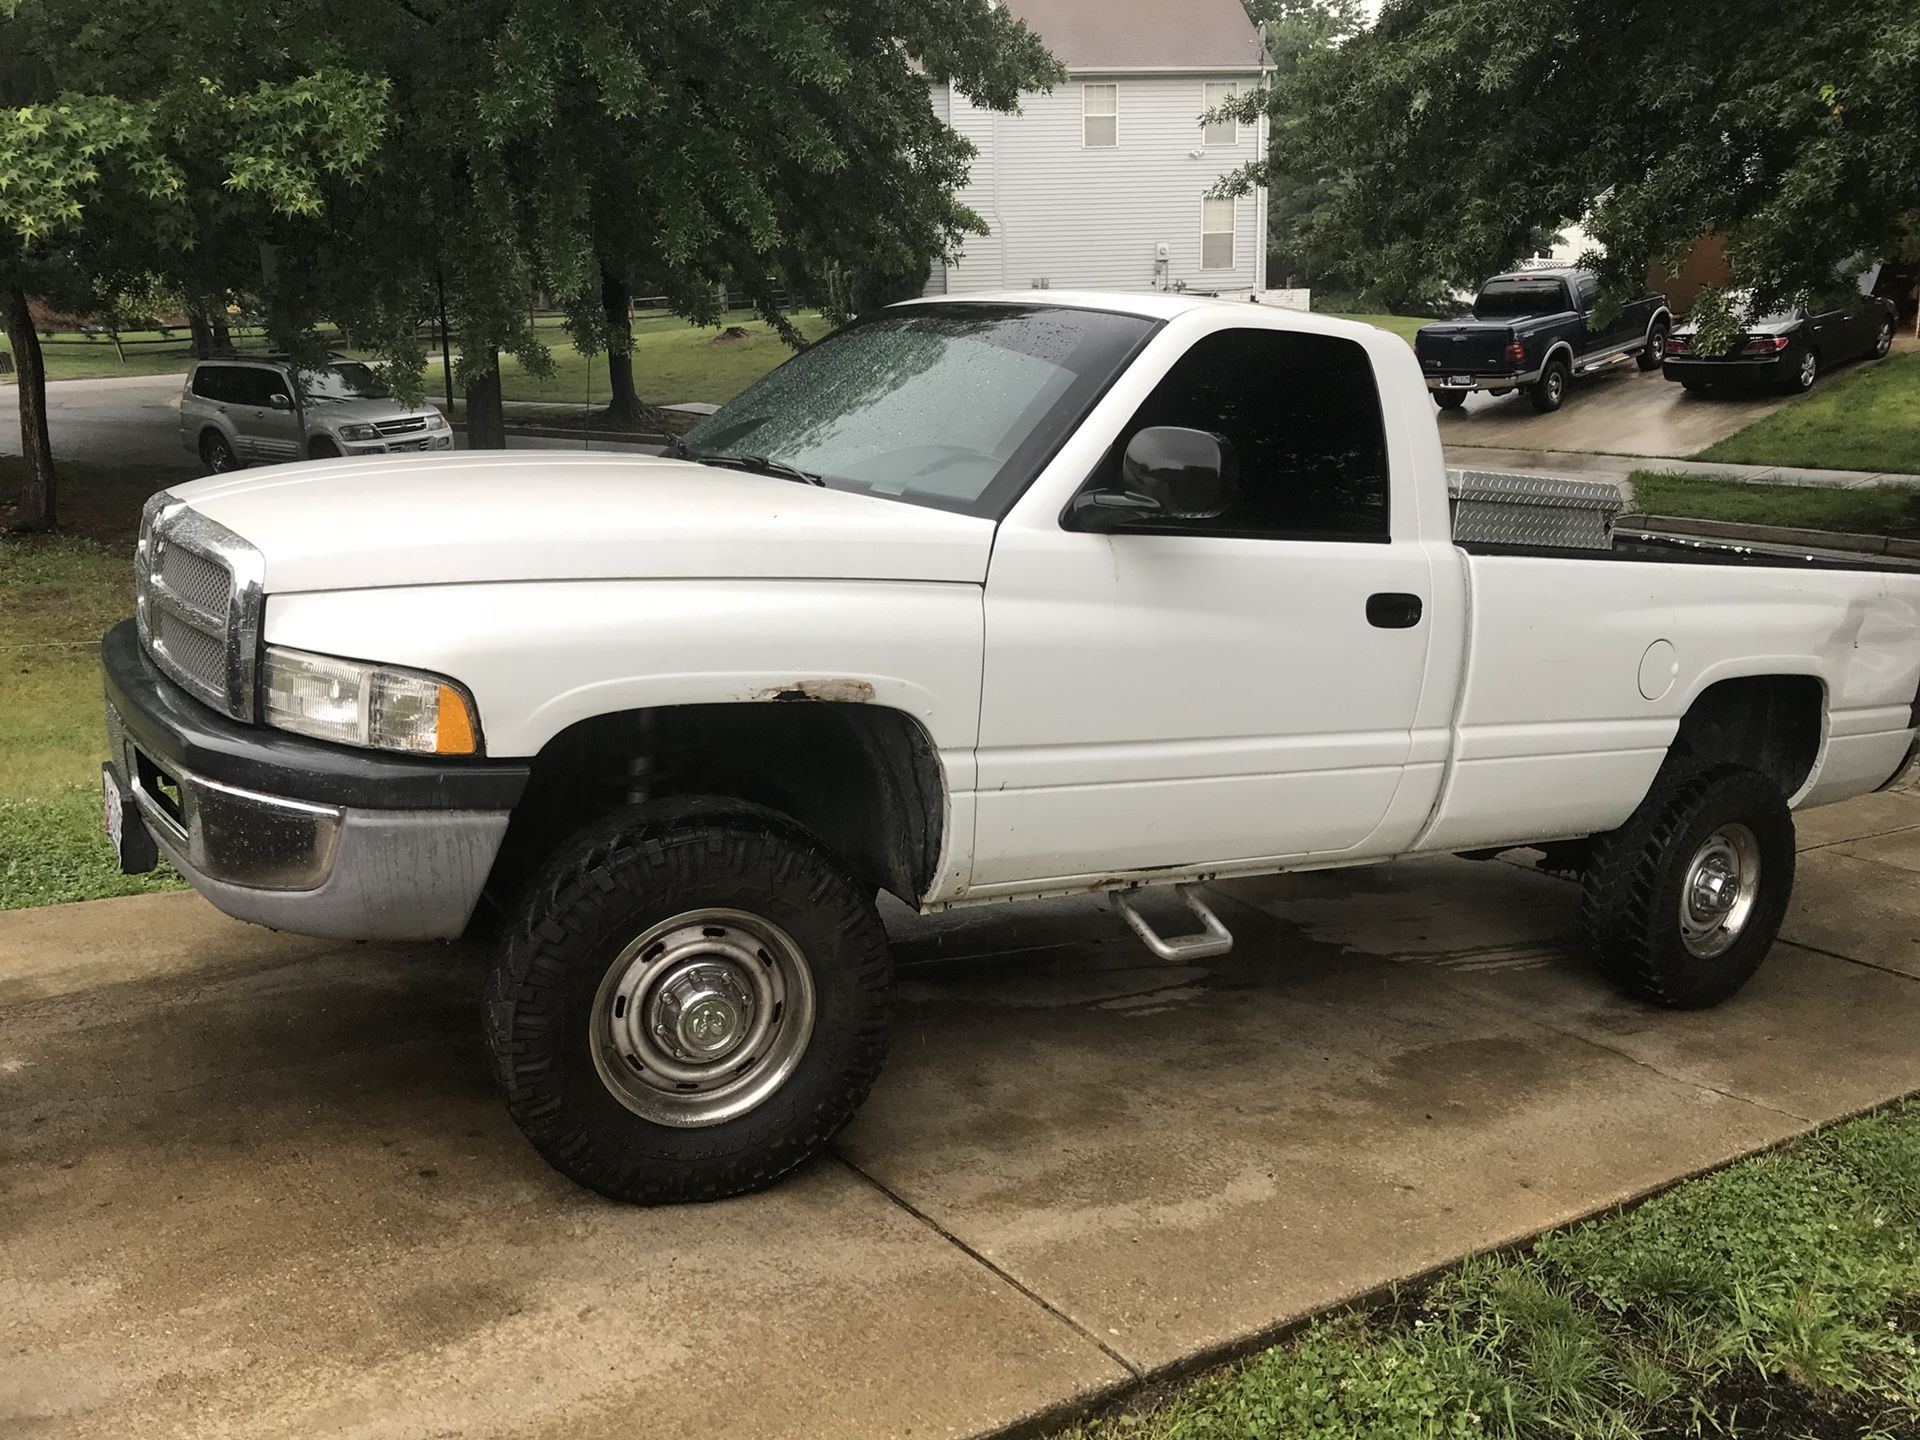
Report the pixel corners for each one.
[102,620,528,941]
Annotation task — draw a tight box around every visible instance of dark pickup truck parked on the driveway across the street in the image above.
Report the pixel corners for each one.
[1413,269,1672,411]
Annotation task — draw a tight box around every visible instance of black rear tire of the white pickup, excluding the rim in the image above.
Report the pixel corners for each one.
[1580,764,1793,1010]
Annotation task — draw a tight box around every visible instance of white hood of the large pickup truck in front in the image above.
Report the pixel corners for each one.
[173,451,993,593]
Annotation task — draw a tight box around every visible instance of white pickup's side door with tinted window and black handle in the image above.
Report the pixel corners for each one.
[972,326,1432,893]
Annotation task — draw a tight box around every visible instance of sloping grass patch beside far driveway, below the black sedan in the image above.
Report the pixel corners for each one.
[1693,351,1920,474]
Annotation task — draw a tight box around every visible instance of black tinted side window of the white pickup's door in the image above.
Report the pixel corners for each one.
[1098,330,1388,541]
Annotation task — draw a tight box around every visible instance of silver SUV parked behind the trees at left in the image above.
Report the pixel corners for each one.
[180,355,453,474]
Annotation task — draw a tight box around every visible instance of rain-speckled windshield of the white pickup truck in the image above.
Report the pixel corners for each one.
[685,303,1156,515]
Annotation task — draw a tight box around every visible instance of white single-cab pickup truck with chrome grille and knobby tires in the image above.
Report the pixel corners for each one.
[104,292,1920,1200]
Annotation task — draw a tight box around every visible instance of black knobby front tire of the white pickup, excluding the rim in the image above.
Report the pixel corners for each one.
[484,799,893,1204]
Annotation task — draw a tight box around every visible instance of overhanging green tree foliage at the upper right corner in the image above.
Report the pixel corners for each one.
[1238,0,1920,305]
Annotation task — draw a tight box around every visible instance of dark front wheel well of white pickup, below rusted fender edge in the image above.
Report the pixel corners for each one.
[488,706,947,904]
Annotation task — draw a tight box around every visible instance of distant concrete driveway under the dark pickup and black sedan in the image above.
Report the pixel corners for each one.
[1436,365,1788,457]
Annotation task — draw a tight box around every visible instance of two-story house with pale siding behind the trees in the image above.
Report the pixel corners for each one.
[927,0,1267,294]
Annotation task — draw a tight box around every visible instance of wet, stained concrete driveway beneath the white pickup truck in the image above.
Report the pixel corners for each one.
[0,793,1920,1440]
